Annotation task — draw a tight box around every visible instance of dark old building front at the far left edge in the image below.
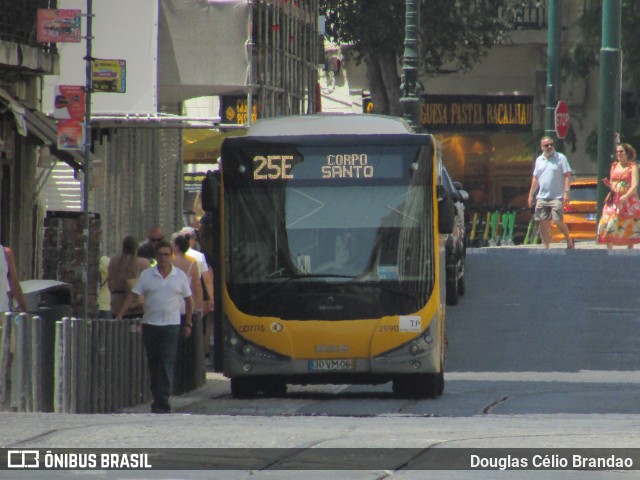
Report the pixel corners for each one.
[0,0,63,278]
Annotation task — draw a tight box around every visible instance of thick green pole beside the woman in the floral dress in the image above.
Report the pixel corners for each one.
[598,0,622,221]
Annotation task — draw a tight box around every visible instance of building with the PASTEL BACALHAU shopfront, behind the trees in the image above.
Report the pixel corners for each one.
[321,1,598,237]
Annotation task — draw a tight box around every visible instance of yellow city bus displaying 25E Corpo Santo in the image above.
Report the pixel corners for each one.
[203,114,453,398]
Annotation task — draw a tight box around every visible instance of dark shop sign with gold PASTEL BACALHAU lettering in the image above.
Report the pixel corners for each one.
[420,95,533,133]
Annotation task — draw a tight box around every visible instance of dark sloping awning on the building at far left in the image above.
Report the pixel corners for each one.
[0,88,84,170]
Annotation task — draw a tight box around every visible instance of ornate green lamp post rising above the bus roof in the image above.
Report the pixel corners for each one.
[400,0,422,133]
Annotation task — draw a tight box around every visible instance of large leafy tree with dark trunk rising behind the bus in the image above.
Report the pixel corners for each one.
[320,0,530,115]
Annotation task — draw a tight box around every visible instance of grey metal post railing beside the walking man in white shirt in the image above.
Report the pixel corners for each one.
[0,313,206,413]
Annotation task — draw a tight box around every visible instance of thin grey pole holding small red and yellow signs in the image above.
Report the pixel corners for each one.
[82,0,93,320]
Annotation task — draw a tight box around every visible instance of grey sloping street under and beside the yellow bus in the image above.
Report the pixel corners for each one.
[0,245,640,479]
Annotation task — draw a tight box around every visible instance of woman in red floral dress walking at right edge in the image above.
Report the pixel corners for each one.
[598,143,640,248]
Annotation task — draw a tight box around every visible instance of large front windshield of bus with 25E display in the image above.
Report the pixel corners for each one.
[222,141,435,320]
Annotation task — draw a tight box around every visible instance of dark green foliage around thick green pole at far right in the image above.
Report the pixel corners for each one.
[562,0,640,161]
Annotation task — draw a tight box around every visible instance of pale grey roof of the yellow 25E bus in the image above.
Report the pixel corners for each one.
[246,113,414,137]
